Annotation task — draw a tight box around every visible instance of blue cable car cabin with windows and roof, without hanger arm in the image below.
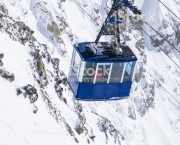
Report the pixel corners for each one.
[68,42,137,100]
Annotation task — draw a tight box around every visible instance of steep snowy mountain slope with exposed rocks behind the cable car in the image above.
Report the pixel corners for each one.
[0,0,180,145]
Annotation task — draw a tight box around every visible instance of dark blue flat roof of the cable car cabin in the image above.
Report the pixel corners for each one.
[74,42,137,63]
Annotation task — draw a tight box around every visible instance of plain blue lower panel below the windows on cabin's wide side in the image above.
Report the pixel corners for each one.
[76,82,132,100]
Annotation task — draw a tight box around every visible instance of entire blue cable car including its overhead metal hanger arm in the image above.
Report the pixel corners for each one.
[68,0,140,100]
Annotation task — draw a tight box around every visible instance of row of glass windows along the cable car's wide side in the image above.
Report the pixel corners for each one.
[80,62,135,83]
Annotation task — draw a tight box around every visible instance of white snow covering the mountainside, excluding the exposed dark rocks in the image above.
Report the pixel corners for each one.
[0,0,180,145]
